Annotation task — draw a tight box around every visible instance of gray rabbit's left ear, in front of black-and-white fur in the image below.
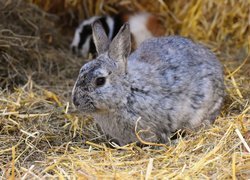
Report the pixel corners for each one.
[92,20,110,54]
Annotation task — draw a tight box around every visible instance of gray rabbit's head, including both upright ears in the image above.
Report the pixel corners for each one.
[72,21,131,113]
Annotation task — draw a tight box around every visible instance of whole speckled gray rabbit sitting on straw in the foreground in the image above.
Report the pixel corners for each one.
[72,21,224,145]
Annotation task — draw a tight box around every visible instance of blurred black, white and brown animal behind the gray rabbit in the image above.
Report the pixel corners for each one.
[70,13,164,57]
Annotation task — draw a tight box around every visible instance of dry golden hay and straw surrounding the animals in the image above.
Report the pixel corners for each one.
[0,0,250,179]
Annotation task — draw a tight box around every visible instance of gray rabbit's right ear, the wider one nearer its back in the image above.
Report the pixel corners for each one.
[108,23,131,66]
